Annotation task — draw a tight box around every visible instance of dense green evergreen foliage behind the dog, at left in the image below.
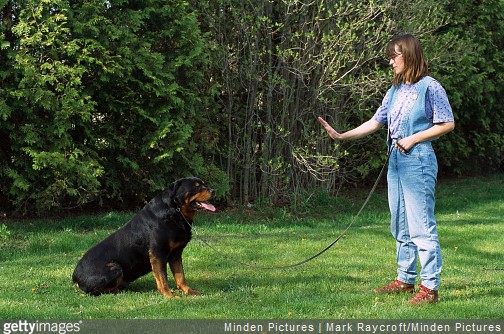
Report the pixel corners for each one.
[0,0,219,211]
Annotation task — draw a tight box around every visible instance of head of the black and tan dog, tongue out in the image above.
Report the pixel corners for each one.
[169,177,215,219]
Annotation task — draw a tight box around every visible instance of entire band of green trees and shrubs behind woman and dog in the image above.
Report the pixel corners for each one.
[0,0,504,213]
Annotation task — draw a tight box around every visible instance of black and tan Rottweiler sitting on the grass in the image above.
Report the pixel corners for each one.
[72,177,215,298]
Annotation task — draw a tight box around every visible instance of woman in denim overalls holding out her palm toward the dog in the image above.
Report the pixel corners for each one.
[318,34,455,304]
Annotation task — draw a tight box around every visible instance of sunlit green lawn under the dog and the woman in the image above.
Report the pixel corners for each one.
[0,175,504,319]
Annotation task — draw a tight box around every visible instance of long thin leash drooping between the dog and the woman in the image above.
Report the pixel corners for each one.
[177,147,392,269]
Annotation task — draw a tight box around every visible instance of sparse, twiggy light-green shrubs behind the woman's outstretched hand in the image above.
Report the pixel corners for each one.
[202,0,456,204]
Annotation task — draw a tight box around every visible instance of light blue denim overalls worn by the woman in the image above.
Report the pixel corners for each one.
[387,77,442,290]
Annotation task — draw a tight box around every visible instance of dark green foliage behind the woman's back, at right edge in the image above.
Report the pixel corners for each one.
[433,0,504,175]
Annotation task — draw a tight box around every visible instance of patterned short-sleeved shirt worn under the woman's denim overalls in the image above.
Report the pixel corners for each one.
[373,80,454,139]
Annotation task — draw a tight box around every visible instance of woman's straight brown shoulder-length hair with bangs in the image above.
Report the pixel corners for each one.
[386,34,429,86]
